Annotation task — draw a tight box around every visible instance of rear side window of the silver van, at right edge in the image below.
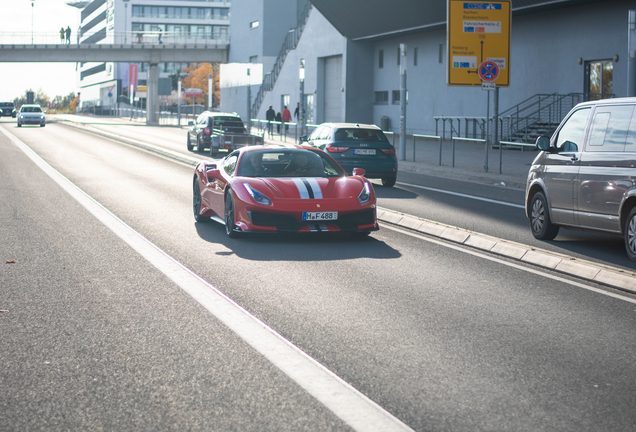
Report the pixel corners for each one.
[587,105,634,152]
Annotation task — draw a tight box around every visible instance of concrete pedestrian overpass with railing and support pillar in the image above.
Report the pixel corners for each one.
[0,32,229,124]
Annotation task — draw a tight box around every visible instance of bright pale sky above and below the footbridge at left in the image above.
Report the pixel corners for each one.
[0,0,80,101]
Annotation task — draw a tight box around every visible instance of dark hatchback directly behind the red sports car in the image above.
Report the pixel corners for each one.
[307,123,398,187]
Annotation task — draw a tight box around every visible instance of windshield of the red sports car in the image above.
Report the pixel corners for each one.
[238,149,346,177]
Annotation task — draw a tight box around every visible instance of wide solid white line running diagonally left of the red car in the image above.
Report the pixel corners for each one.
[0,127,412,432]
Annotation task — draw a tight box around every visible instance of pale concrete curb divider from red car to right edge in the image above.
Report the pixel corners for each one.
[377,207,636,293]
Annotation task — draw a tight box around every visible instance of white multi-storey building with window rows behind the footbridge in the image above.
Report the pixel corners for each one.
[77,0,231,107]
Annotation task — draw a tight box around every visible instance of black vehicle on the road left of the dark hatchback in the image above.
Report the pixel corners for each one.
[187,111,263,157]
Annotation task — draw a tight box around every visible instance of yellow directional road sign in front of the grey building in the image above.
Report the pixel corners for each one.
[446,0,512,87]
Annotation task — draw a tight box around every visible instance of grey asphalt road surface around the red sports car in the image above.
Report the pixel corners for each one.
[0,122,636,431]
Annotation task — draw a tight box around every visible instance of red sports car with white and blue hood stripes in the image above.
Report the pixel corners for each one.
[193,146,379,237]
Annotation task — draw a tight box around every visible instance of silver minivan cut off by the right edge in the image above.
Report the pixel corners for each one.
[526,98,636,261]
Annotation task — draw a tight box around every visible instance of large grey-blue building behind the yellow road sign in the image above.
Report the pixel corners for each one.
[221,0,636,138]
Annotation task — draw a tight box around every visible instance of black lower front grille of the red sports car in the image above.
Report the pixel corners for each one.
[247,209,375,231]
